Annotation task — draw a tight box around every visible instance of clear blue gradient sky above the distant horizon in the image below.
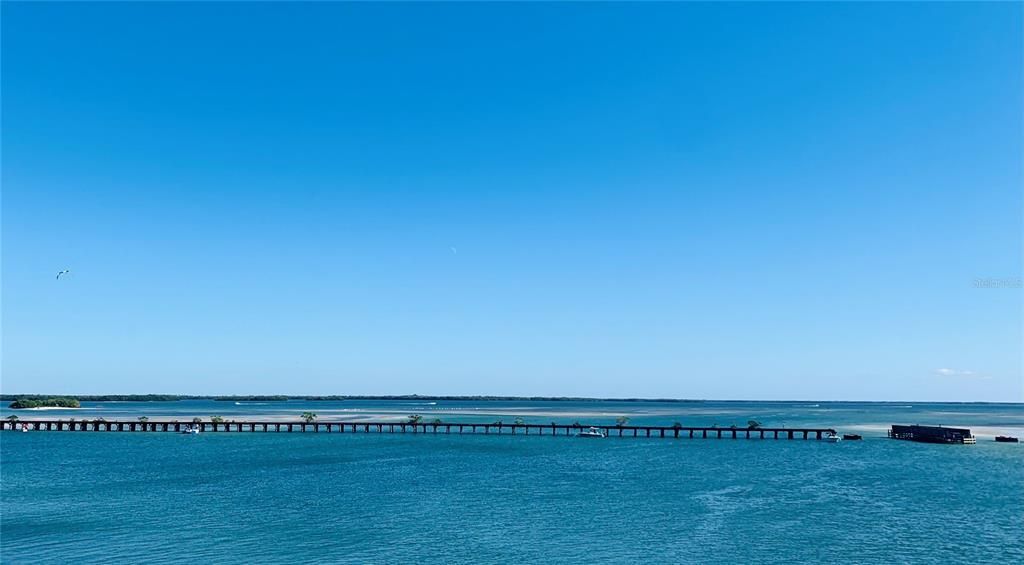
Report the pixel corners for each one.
[2,2,1024,401]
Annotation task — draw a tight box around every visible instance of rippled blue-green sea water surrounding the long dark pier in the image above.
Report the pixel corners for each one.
[0,401,1024,563]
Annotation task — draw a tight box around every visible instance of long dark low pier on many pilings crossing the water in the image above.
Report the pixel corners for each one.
[0,420,836,439]
